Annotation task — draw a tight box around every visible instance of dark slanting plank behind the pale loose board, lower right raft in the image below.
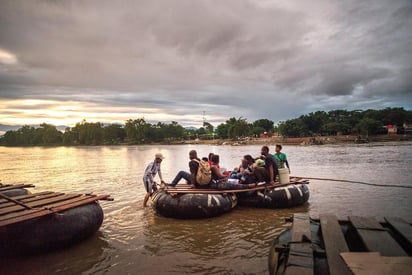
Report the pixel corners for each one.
[349,216,407,256]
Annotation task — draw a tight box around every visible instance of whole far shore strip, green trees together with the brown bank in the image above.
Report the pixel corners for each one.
[0,108,412,146]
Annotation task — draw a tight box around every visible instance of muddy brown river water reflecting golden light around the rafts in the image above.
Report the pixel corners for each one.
[0,142,412,274]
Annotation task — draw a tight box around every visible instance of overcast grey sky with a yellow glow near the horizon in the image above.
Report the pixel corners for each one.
[0,0,412,129]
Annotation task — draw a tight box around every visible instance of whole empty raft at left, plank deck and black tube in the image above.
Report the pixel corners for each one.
[0,185,111,256]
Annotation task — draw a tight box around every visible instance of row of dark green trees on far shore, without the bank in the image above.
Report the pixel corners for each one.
[0,108,412,146]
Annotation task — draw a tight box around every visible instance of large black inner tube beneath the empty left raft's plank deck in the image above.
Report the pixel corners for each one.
[0,202,103,256]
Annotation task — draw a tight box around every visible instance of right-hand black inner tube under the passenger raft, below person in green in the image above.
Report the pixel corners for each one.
[238,184,309,208]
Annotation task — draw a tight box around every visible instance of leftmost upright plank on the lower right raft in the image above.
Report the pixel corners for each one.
[285,213,313,275]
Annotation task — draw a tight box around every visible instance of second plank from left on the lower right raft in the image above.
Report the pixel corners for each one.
[320,215,352,275]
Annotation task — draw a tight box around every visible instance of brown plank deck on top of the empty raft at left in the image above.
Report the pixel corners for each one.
[0,184,112,228]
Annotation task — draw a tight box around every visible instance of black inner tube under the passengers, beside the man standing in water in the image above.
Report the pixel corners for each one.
[152,190,237,219]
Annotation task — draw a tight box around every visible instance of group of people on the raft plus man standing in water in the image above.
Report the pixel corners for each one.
[143,144,290,207]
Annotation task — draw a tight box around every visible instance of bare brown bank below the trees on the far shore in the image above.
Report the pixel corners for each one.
[178,135,412,146]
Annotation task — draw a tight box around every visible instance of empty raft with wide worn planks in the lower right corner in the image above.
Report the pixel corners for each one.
[269,214,412,275]
